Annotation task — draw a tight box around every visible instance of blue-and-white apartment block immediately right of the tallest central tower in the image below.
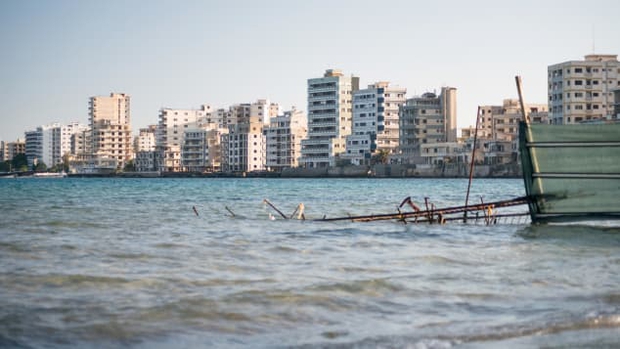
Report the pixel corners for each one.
[343,82,407,165]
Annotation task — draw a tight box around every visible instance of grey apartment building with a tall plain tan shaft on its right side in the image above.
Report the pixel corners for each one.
[399,87,456,163]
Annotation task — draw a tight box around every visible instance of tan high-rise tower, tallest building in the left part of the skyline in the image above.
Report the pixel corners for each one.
[88,93,133,169]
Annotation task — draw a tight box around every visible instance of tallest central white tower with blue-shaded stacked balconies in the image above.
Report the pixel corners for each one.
[300,69,359,168]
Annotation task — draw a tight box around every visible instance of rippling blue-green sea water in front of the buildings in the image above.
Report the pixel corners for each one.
[0,178,620,348]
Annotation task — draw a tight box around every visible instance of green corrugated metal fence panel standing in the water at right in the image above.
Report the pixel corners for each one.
[519,122,620,223]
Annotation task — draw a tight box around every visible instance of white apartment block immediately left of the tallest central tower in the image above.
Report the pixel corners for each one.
[265,108,308,172]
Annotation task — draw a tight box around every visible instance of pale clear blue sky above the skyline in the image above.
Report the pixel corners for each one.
[0,0,620,141]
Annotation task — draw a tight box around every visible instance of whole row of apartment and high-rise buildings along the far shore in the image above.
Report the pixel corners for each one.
[7,55,620,172]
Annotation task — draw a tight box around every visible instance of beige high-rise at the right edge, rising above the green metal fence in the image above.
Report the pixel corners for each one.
[547,54,620,124]
